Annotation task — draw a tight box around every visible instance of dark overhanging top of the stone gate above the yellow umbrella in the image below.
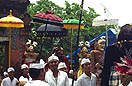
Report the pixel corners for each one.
[0,0,30,16]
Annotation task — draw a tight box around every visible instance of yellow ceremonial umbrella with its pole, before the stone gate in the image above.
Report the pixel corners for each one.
[0,10,24,67]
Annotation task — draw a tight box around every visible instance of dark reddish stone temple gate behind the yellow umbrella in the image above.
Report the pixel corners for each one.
[0,0,31,69]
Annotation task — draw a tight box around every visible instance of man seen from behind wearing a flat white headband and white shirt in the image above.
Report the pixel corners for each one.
[24,63,50,86]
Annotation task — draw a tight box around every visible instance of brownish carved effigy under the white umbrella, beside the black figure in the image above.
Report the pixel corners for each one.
[90,36,106,86]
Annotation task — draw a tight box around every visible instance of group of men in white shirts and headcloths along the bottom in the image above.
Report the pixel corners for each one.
[1,54,96,86]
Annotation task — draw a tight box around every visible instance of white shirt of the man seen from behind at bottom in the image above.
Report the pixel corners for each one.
[24,80,50,86]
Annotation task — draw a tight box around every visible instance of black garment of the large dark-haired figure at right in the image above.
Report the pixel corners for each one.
[101,44,124,86]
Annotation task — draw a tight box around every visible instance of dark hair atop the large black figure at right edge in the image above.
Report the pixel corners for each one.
[117,24,132,41]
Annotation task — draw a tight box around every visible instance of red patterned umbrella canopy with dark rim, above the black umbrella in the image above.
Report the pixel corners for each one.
[33,11,63,26]
